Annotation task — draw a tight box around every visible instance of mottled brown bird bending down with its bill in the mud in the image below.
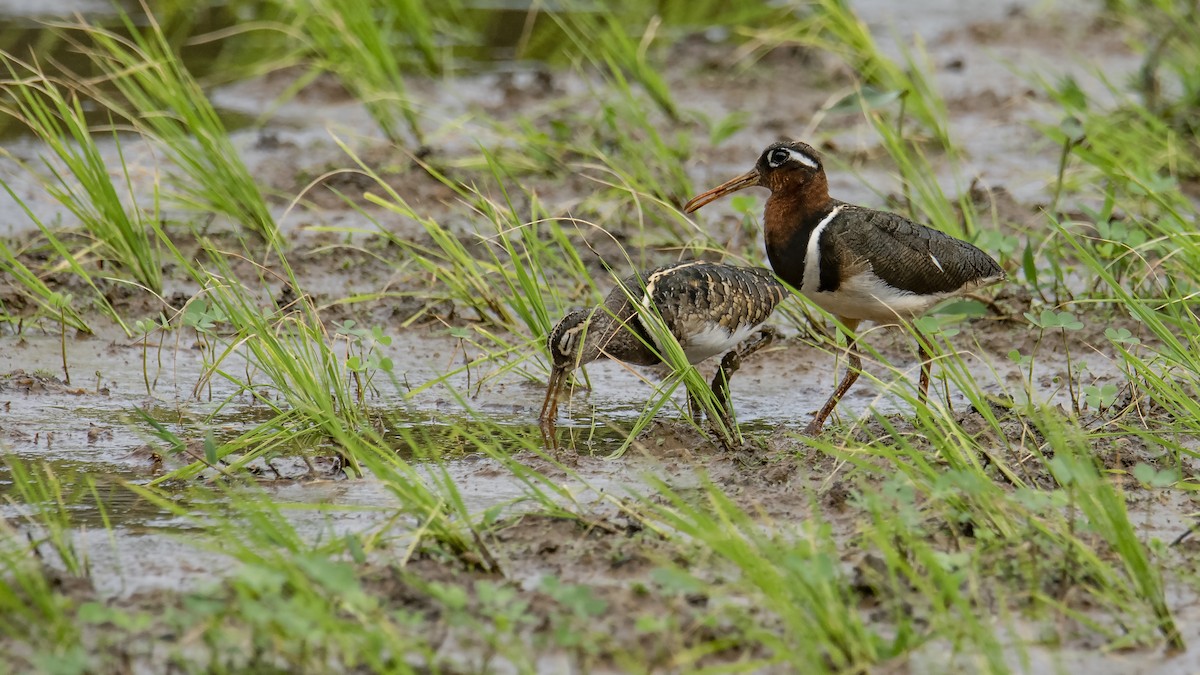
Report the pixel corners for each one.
[540,261,787,447]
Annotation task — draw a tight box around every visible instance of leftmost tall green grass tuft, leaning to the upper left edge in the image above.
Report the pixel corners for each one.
[0,53,162,294]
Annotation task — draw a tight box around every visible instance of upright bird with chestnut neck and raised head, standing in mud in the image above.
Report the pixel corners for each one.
[684,141,1004,436]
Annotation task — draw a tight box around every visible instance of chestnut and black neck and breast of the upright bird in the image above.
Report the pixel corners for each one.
[763,175,838,283]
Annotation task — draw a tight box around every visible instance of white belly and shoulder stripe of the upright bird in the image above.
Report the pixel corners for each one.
[800,207,954,323]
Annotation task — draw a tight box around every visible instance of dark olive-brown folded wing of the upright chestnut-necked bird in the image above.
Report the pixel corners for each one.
[821,205,1004,294]
